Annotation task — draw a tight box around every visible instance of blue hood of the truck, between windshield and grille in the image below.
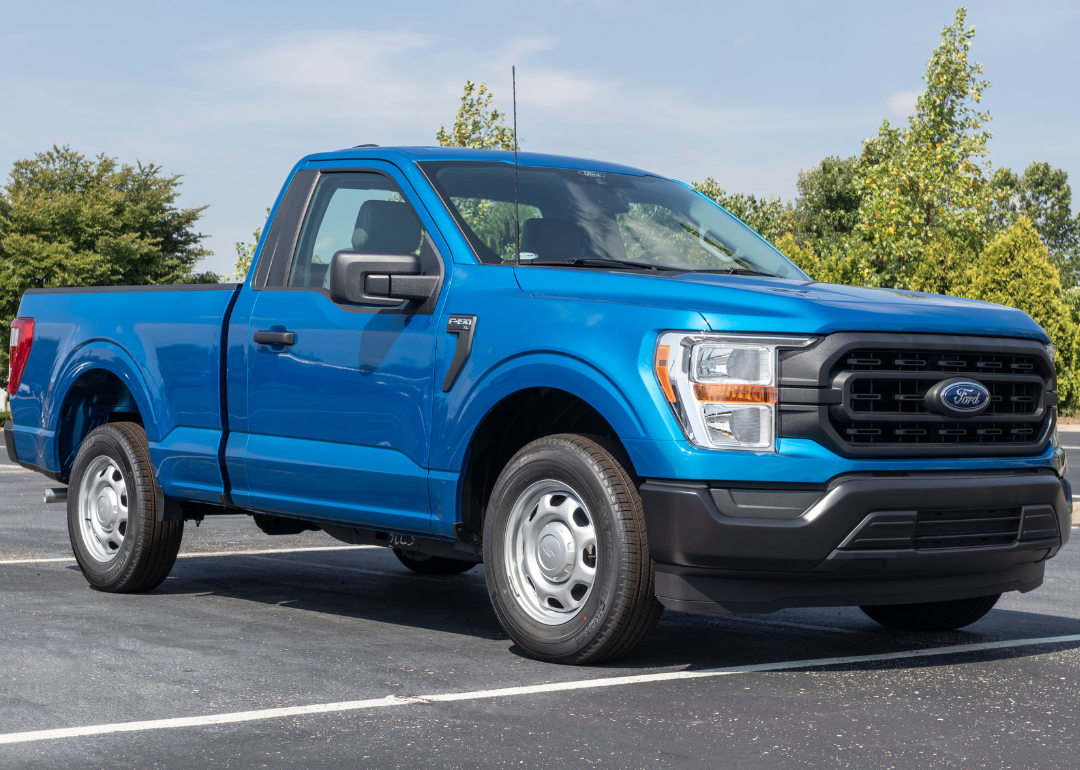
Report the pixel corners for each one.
[516,267,1050,342]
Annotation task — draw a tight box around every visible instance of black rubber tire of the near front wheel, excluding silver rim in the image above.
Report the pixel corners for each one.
[484,433,663,664]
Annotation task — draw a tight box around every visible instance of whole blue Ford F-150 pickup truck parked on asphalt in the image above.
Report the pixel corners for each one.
[4,146,1072,663]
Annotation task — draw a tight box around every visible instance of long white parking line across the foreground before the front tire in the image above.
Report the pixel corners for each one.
[0,634,1080,744]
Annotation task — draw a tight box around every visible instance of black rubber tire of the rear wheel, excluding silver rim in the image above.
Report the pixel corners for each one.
[68,422,184,593]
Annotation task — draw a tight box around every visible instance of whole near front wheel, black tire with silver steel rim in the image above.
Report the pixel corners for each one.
[484,434,663,663]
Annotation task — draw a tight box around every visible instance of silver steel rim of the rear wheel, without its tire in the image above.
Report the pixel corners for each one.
[79,456,127,564]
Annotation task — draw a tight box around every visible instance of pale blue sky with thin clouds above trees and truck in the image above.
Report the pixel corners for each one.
[0,0,1080,273]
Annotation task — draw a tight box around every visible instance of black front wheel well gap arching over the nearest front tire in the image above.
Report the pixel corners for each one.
[459,388,634,540]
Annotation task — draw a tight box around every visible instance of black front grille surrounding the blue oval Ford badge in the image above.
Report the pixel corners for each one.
[779,334,1056,456]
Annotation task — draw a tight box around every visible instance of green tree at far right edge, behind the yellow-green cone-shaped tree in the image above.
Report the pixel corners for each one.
[990,163,1080,286]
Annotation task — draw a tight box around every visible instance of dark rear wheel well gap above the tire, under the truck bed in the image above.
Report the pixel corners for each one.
[57,369,143,478]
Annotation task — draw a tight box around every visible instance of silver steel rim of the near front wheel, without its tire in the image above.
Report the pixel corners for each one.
[503,479,596,625]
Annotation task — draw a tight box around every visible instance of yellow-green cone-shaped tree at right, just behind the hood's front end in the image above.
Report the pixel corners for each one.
[953,217,1080,414]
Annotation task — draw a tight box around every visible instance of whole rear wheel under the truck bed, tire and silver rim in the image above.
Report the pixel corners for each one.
[68,422,184,593]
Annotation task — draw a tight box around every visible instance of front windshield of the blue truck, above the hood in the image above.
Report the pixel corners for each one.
[420,161,806,280]
